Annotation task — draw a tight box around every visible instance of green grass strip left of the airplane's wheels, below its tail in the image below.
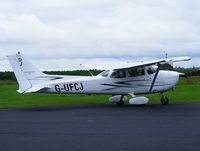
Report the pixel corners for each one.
[0,84,109,108]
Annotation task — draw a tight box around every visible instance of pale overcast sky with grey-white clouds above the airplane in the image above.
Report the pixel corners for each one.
[0,0,200,70]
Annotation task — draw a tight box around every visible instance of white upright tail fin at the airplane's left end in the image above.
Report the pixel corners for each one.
[7,53,45,93]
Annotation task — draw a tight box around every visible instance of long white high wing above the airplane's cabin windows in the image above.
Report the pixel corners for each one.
[82,56,191,70]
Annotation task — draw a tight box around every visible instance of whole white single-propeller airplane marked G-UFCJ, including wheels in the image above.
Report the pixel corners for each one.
[7,52,191,106]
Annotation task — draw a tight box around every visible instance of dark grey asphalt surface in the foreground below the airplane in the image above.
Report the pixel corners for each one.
[0,103,200,151]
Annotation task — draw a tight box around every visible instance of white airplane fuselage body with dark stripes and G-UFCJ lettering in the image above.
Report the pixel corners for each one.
[37,70,180,95]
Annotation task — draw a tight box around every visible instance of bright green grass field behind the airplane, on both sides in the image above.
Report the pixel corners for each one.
[0,76,200,108]
